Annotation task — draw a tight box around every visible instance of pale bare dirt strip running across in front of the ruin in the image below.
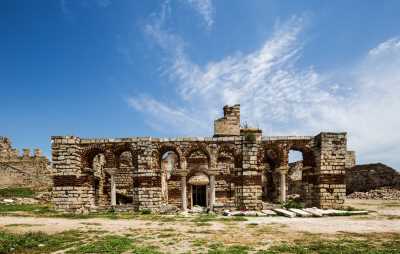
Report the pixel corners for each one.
[0,200,400,253]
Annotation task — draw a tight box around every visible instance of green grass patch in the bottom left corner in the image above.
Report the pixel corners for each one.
[0,231,80,254]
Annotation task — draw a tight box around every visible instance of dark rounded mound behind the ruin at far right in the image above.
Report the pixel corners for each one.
[346,163,400,194]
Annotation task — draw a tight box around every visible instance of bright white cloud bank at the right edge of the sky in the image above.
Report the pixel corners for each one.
[310,38,400,168]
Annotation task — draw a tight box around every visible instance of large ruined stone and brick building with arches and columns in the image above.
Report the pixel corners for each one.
[52,105,347,211]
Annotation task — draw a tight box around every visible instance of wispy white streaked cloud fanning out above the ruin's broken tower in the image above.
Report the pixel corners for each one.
[130,17,331,134]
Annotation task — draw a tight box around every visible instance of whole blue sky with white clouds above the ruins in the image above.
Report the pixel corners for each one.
[0,0,400,168]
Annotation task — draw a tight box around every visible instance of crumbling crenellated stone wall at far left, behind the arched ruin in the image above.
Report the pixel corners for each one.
[0,137,52,189]
